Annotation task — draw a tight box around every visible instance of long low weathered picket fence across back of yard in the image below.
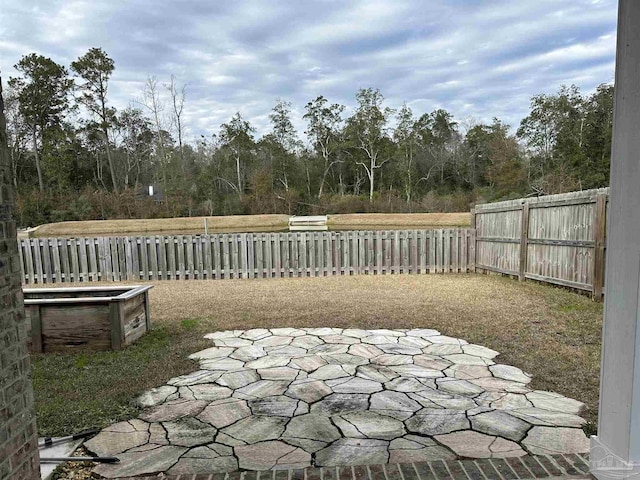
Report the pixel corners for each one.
[20,229,475,284]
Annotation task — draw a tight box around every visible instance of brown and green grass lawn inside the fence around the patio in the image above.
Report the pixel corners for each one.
[32,275,602,435]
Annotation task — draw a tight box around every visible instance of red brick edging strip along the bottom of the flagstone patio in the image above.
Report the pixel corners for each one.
[119,454,592,480]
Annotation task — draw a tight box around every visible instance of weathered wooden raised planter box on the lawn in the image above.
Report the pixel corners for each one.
[23,285,153,352]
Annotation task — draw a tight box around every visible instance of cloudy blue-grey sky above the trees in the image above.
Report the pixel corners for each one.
[0,0,617,142]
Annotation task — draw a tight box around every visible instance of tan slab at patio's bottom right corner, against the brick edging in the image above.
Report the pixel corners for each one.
[522,427,589,455]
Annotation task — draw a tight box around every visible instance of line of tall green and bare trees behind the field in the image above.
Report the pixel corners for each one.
[5,48,613,226]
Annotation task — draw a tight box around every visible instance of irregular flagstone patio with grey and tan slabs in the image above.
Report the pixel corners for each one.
[85,328,589,478]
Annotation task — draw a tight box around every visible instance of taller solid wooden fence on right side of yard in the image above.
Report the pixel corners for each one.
[471,188,609,300]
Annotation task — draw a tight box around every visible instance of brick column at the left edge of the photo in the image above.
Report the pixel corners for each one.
[0,81,40,480]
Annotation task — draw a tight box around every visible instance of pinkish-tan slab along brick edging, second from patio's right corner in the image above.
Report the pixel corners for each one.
[435,431,526,458]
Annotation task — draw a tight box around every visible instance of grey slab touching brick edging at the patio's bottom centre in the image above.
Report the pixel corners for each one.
[315,438,389,467]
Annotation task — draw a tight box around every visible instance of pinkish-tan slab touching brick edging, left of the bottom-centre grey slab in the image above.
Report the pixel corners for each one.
[235,442,311,470]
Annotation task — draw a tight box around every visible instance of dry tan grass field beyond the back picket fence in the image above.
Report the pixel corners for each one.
[31,212,470,237]
